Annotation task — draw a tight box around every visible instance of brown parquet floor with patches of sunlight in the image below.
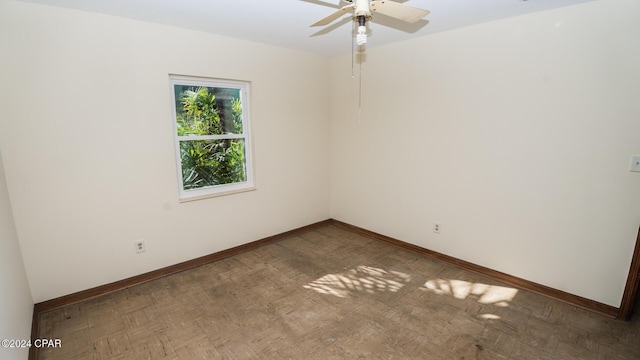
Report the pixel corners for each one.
[39,226,640,360]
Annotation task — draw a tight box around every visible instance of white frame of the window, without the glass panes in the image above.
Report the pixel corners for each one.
[169,75,255,202]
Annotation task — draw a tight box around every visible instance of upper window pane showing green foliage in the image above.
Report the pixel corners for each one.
[174,85,243,136]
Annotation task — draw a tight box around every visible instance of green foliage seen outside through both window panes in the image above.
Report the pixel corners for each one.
[175,85,247,190]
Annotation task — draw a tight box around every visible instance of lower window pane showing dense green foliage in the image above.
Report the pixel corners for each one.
[180,139,247,190]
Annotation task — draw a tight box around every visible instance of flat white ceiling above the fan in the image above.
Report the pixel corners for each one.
[16,0,594,55]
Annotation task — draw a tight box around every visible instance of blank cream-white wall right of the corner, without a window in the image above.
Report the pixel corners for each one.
[331,0,640,307]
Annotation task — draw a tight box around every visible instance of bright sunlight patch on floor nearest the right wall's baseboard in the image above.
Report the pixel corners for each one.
[423,279,518,307]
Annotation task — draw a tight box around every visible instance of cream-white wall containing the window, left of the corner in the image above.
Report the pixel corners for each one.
[0,0,330,302]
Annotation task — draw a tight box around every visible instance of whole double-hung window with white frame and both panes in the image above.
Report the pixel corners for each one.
[170,75,254,200]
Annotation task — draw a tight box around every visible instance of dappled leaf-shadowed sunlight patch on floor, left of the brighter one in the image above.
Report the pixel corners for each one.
[303,265,411,298]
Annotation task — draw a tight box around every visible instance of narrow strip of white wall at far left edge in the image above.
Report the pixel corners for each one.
[0,147,33,360]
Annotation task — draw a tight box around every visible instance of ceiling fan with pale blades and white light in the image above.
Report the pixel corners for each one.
[311,0,429,45]
